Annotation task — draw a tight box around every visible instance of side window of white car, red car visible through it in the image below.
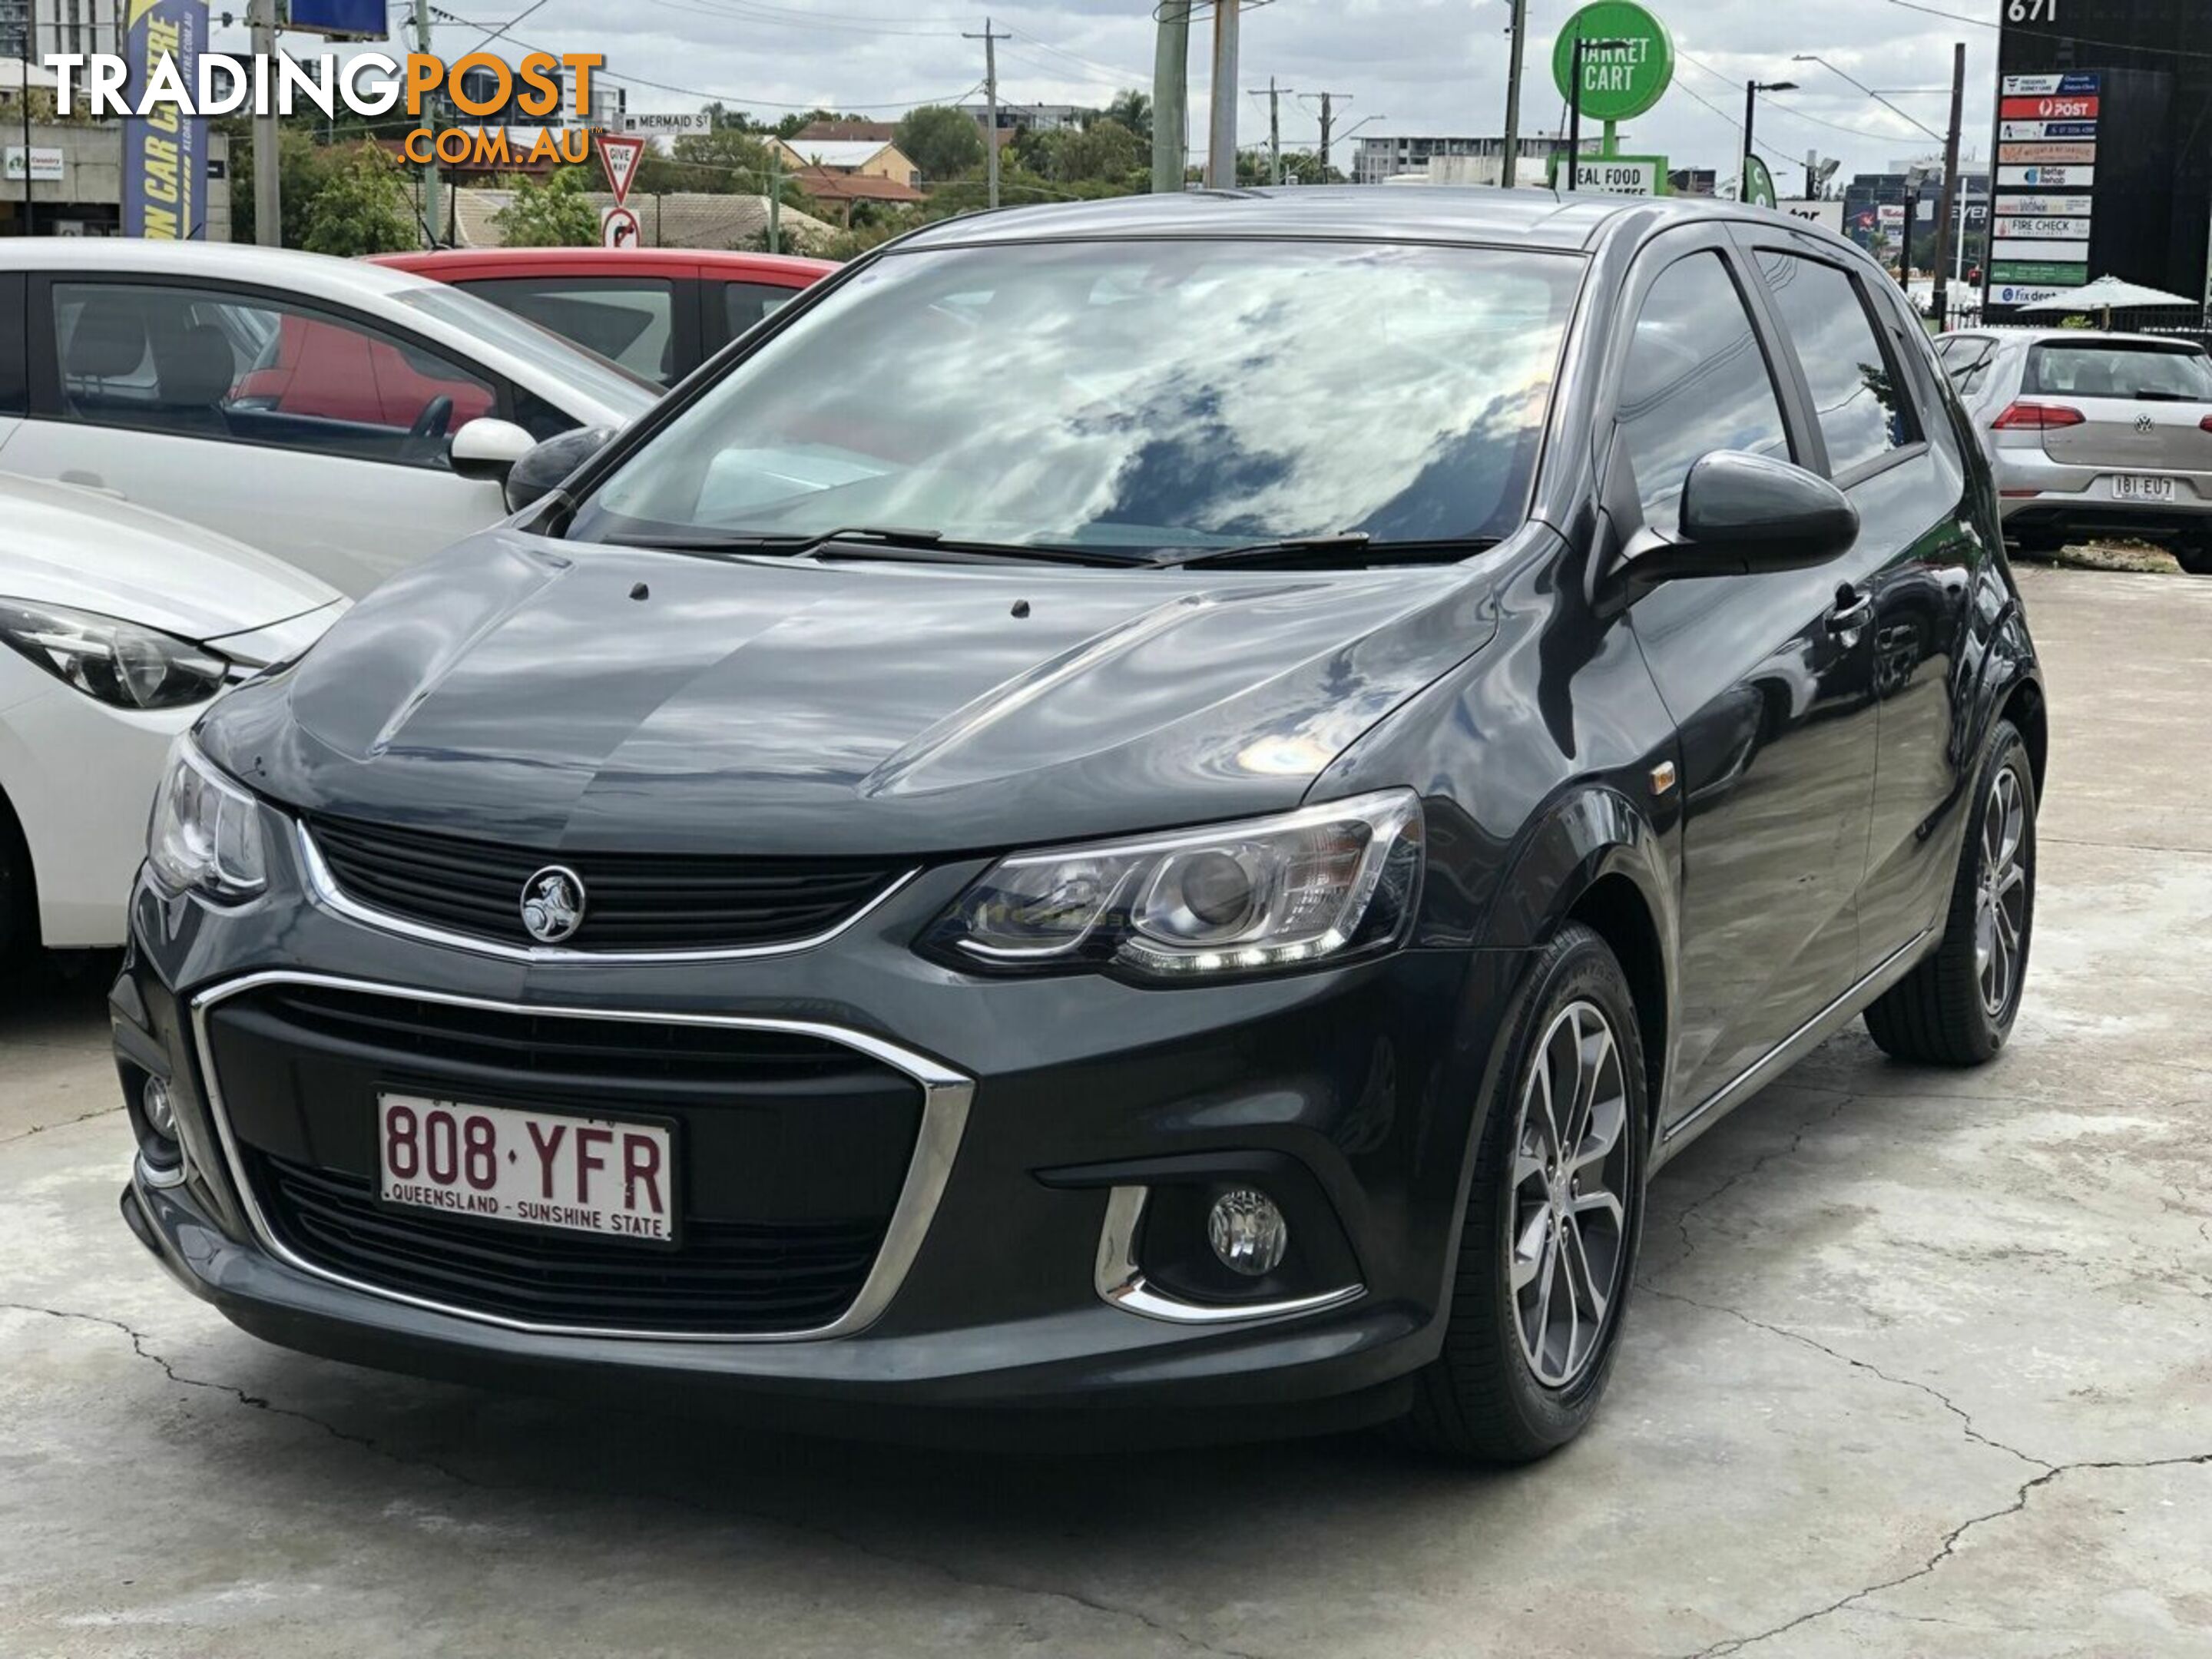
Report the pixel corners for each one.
[53,283,498,469]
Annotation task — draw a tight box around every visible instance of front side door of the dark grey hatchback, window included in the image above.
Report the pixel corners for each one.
[1606,230,1876,1115]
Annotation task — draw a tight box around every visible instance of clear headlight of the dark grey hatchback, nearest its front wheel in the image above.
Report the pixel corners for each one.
[927,790,1422,980]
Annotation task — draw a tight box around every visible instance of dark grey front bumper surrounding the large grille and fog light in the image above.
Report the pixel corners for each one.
[113,858,1522,1442]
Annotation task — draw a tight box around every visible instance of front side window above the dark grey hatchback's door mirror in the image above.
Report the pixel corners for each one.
[1619,254,1790,531]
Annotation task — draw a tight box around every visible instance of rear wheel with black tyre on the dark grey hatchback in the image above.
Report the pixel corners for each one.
[1867,721,2035,1066]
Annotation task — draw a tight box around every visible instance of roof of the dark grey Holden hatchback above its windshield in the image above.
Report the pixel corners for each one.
[900,184,1774,250]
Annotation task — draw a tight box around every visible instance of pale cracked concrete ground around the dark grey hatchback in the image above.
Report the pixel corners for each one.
[0,568,2212,1659]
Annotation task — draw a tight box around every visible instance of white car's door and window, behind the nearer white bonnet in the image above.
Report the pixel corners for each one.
[0,272,511,595]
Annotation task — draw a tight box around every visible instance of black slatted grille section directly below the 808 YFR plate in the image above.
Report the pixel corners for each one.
[252,1152,882,1336]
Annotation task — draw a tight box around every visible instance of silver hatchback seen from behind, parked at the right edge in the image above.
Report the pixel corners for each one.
[1936,327,2212,575]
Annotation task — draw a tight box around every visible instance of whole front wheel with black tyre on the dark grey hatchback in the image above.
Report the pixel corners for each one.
[1398,925,1650,1462]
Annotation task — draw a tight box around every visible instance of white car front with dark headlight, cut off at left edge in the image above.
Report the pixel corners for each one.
[0,475,347,955]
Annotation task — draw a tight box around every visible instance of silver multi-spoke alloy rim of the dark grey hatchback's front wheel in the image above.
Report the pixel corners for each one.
[1506,1002,1631,1389]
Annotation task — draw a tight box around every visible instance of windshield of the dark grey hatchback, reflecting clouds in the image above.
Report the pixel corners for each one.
[571,241,1581,558]
